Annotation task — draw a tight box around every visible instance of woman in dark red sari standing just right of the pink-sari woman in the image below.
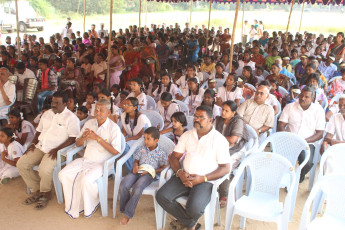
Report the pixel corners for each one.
[121,43,140,88]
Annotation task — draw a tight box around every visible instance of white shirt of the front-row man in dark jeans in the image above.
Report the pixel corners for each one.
[174,127,231,175]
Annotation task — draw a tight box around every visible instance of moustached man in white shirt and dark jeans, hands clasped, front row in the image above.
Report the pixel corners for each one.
[156,106,231,229]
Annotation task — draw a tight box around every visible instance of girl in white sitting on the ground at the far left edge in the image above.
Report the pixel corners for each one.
[0,127,24,184]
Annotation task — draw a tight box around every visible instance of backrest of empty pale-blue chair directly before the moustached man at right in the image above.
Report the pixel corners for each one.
[258,132,310,165]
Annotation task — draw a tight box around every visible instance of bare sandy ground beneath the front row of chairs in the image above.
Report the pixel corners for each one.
[0,172,309,230]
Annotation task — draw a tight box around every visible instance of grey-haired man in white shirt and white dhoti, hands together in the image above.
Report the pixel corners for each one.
[59,99,121,218]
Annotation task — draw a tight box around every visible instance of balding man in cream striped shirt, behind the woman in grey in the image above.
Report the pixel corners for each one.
[238,85,274,135]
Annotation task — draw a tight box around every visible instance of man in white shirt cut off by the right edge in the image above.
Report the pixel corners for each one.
[321,94,345,153]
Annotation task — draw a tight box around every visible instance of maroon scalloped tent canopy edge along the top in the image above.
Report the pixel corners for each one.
[148,0,345,5]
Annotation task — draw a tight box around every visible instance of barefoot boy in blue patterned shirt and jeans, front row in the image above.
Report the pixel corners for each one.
[120,127,167,225]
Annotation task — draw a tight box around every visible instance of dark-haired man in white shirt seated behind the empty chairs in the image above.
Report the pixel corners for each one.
[278,86,326,183]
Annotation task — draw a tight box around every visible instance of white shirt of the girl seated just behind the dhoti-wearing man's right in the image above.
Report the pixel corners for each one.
[121,113,151,137]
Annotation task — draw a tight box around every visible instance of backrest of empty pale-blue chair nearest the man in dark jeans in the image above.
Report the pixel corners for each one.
[238,152,295,199]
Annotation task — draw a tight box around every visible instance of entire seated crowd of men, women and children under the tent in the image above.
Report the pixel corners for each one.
[0,21,345,229]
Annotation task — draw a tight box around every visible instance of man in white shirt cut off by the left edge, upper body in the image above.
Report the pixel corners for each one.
[0,67,16,117]
